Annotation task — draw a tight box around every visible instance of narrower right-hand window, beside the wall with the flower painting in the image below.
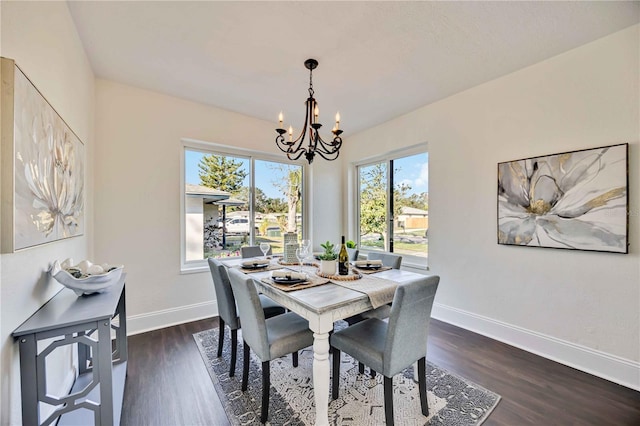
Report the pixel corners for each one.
[356,151,429,266]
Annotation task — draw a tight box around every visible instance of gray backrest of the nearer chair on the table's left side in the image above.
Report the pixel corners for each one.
[229,269,271,360]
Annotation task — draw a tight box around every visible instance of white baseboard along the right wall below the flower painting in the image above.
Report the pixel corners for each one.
[432,303,640,391]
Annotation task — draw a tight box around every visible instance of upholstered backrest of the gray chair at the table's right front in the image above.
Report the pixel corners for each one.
[382,275,440,377]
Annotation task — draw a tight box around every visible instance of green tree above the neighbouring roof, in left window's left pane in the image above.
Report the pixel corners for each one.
[198,154,248,195]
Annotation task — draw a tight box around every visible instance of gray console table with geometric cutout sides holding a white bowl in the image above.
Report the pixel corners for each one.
[13,274,127,426]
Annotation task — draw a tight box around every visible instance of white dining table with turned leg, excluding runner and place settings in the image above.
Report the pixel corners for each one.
[222,258,422,426]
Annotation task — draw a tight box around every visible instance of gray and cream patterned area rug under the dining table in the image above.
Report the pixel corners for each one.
[193,323,500,426]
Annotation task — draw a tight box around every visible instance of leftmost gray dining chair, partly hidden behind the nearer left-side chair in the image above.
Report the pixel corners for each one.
[209,257,284,377]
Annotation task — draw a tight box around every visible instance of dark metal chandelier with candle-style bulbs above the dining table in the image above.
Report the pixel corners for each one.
[276,59,342,164]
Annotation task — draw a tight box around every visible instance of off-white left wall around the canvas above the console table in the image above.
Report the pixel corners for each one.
[0,1,94,425]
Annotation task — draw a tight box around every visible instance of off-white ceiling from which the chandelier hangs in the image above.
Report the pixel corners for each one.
[68,1,640,137]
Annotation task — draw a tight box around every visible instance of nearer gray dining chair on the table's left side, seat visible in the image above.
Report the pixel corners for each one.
[229,269,313,423]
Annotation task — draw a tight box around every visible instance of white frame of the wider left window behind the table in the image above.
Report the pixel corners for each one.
[180,138,309,274]
